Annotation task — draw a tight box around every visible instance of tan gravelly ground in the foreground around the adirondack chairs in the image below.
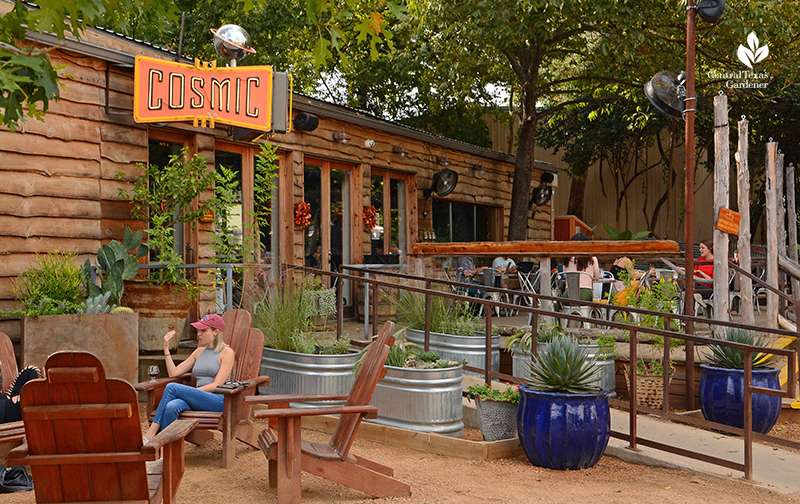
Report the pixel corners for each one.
[6,414,800,504]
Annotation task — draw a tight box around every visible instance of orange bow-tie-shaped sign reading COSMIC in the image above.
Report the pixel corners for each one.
[133,56,272,131]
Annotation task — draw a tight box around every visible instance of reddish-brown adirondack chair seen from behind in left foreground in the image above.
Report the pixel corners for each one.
[8,352,196,504]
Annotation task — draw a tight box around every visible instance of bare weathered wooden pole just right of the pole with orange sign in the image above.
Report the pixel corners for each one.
[736,116,755,325]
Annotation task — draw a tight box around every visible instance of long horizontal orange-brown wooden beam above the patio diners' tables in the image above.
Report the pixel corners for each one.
[411,240,681,258]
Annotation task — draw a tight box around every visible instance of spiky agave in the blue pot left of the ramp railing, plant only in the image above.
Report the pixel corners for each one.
[529,336,600,394]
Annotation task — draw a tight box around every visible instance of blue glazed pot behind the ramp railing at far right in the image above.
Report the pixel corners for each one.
[699,365,781,434]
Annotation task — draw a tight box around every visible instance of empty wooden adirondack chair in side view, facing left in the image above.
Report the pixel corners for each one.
[247,321,411,504]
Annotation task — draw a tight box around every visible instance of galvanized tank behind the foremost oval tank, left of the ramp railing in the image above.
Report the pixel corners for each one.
[406,329,500,376]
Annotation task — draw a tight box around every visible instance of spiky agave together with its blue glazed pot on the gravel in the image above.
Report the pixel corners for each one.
[517,336,611,469]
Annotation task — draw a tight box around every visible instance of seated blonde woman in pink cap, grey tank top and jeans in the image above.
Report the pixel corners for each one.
[144,313,234,444]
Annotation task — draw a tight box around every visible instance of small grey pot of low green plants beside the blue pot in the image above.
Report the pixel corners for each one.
[467,383,519,441]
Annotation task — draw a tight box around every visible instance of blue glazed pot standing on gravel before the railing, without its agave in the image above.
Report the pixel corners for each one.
[517,385,611,469]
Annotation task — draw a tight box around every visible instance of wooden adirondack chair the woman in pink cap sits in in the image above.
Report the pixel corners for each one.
[136,310,269,468]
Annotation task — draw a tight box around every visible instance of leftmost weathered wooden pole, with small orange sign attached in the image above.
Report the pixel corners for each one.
[713,94,731,333]
